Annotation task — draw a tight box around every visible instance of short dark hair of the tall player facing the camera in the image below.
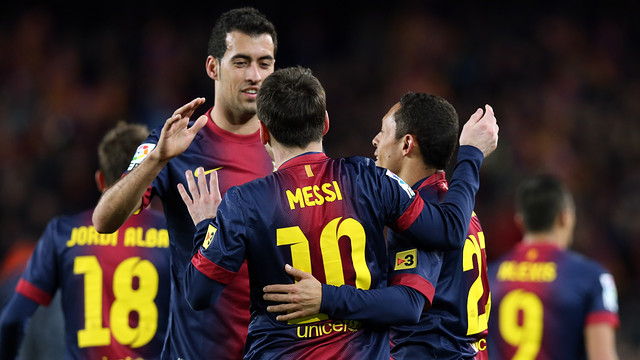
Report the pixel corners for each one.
[208,7,278,59]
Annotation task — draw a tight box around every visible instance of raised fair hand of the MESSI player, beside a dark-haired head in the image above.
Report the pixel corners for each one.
[460,105,499,158]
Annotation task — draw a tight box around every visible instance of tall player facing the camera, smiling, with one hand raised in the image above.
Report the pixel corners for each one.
[93,8,277,360]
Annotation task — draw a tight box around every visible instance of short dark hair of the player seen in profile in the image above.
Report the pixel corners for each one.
[394,92,459,169]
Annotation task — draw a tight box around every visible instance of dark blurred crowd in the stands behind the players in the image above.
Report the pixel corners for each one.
[0,0,640,359]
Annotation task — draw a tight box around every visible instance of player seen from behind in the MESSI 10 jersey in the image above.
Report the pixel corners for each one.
[178,68,498,359]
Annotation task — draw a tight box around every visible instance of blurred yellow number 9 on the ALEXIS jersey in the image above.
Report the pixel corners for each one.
[499,289,544,360]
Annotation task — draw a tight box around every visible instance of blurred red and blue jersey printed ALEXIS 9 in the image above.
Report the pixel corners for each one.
[488,243,619,360]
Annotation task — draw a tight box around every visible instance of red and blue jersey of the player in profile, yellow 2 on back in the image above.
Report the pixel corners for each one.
[387,172,491,360]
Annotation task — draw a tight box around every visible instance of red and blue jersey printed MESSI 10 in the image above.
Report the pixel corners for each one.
[187,148,481,359]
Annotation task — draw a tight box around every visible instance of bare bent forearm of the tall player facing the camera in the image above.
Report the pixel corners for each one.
[92,152,168,233]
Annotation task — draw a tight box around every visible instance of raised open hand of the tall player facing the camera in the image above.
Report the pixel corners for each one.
[153,98,207,162]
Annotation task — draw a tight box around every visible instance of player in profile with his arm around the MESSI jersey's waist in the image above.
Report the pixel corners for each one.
[265,92,490,359]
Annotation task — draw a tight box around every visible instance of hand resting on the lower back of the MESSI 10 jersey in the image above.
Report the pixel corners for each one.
[262,264,322,321]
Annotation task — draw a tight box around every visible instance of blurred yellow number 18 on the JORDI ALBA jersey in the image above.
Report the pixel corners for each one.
[73,256,158,348]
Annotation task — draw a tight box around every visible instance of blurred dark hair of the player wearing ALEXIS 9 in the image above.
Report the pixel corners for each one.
[516,174,574,232]
